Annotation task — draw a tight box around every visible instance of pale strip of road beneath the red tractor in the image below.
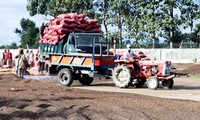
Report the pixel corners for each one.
[73,77,200,101]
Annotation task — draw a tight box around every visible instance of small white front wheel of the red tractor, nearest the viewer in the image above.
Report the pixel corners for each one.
[147,76,159,90]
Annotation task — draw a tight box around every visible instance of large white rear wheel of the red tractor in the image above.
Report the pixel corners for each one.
[112,66,131,88]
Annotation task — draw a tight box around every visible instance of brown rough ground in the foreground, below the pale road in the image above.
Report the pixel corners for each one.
[0,74,200,120]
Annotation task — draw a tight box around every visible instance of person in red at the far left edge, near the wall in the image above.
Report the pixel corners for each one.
[2,49,12,68]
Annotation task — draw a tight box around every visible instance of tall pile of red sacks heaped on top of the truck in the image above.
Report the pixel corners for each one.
[40,13,102,44]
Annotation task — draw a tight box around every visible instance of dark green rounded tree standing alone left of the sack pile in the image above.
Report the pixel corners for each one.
[15,18,39,48]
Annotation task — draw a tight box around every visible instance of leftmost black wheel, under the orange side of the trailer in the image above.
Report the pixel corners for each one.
[58,68,73,86]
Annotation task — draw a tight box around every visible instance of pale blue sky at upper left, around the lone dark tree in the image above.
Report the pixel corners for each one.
[0,0,45,46]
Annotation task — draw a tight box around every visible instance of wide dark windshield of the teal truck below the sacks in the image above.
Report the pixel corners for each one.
[76,34,107,54]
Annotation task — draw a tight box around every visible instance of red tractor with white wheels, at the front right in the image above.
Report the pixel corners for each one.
[112,51,175,90]
